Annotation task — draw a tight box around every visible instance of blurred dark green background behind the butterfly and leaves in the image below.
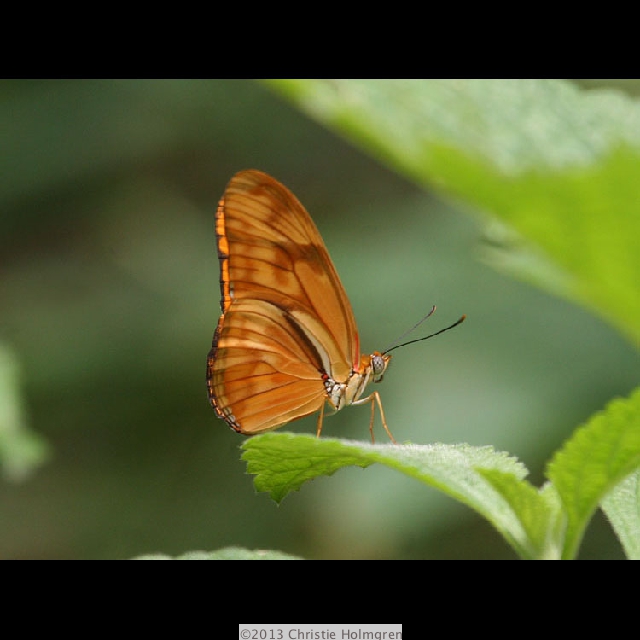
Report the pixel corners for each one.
[0,80,638,559]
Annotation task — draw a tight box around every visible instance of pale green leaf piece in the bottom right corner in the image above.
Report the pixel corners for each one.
[602,469,640,560]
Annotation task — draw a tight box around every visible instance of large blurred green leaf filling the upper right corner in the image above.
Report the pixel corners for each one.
[268,80,640,344]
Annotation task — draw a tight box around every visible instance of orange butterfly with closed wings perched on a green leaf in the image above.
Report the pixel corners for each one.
[207,170,464,443]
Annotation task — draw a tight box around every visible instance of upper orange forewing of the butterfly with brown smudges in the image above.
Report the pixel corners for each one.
[218,171,359,364]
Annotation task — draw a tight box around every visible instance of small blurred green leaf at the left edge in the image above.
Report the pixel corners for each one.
[0,344,48,481]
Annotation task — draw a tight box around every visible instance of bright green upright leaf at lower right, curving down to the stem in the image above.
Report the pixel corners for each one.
[547,388,640,558]
